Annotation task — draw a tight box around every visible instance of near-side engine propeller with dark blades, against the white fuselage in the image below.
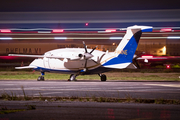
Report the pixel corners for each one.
[79,41,97,71]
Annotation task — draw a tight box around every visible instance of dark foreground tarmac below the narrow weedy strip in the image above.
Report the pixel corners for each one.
[0,101,180,120]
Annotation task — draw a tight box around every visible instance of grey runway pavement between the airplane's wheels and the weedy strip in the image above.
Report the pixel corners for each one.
[0,80,180,99]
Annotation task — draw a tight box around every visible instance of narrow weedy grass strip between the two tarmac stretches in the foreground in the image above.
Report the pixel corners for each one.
[0,96,180,104]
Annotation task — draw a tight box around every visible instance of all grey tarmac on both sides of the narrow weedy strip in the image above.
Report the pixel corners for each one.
[0,80,180,120]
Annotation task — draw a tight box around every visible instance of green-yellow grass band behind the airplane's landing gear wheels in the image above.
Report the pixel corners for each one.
[0,71,180,81]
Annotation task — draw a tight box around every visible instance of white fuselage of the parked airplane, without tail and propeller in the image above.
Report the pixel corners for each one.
[30,48,114,73]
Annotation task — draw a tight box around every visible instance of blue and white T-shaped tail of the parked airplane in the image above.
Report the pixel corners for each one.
[103,25,153,69]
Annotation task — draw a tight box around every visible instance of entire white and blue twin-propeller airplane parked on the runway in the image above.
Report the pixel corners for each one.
[9,25,153,81]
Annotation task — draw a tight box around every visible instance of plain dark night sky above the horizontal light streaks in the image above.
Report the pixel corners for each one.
[0,0,180,12]
